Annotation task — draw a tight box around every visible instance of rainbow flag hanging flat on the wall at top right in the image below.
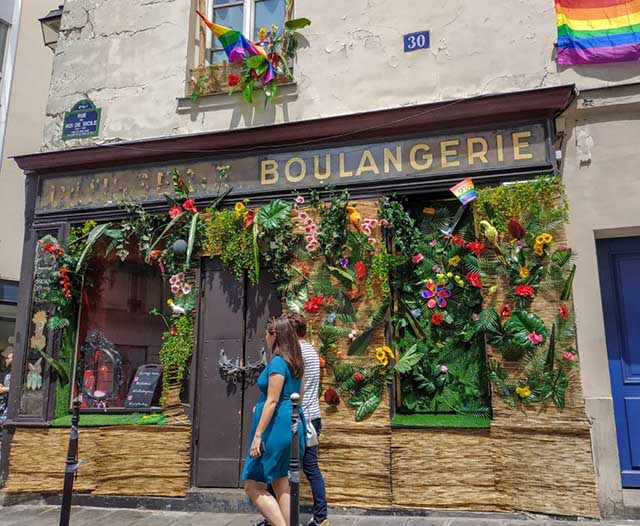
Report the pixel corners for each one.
[555,0,640,66]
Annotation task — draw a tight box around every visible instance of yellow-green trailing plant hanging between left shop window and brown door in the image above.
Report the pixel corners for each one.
[160,315,193,403]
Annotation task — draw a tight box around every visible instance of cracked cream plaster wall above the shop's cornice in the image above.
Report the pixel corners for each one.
[44,0,640,149]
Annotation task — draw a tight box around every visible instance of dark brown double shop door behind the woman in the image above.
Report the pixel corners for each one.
[194,259,281,488]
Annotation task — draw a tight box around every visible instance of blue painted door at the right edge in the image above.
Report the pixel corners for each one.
[597,237,640,488]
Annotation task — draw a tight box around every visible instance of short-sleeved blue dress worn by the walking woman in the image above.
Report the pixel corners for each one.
[242,355,306,484]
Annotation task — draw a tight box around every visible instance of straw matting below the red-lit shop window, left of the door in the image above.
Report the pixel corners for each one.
[5,426,191,497]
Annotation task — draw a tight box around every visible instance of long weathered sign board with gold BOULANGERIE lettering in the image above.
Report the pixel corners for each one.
[38,124,552,210]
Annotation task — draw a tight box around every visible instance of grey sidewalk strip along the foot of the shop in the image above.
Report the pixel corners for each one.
[0,505,640,526]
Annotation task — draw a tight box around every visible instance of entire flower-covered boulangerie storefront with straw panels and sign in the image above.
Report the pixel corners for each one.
[2,86,598,516]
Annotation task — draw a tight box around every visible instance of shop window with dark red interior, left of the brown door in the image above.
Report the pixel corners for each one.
[76,250,170,411]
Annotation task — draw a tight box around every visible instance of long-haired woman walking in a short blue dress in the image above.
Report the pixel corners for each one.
[242,318,305,526]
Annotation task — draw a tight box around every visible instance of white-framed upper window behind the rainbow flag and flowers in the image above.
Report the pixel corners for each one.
[207,0,286,64]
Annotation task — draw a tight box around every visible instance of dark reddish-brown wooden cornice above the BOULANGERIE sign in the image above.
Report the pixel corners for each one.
[15,85,575,174]
